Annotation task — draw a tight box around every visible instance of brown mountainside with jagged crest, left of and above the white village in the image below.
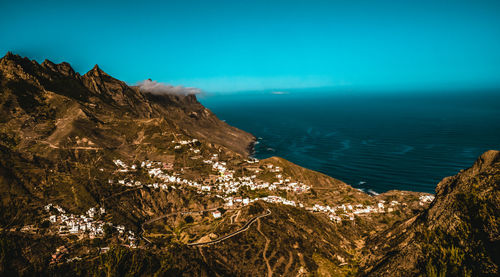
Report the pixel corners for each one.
[0,53,250,226]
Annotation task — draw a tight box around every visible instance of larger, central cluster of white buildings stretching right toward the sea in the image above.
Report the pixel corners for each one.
[110,154,418,223]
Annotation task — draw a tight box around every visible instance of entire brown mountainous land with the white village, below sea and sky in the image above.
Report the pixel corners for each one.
[0,53,499,276]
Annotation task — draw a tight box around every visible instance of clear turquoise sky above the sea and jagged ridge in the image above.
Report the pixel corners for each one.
[0,0,500,93]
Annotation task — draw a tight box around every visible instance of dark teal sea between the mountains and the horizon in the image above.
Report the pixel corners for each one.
[198,90,500,193]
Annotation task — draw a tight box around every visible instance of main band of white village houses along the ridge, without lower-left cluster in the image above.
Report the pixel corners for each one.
[109,135,434,223]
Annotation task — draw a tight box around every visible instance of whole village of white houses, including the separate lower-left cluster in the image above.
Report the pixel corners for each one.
[21,139,434,262]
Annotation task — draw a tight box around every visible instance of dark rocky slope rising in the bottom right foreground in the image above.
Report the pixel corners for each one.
[363,151,500,276]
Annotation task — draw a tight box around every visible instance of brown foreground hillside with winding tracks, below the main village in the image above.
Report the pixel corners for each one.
[51,202,368,276]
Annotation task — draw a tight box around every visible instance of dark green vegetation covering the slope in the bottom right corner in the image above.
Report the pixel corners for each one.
[423,182,500,276]
